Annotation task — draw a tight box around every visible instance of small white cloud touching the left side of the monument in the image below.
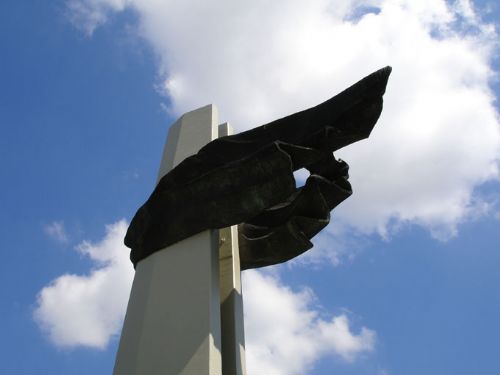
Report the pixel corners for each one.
[34,220,133,349]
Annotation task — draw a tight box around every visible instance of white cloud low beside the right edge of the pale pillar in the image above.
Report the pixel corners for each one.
[243,270,376,375]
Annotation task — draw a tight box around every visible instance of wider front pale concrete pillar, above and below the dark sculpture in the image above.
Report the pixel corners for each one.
[114,105,224,375]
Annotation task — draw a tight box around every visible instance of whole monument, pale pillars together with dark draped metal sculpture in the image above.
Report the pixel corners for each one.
[114,67,391,375]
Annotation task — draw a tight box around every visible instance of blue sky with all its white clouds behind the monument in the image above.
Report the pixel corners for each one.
[0,0,500,375]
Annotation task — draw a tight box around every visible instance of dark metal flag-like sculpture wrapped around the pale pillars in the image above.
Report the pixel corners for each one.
[125,67,391,269]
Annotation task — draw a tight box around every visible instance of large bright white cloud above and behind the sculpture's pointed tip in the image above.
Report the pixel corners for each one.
[65,0,500,245]
